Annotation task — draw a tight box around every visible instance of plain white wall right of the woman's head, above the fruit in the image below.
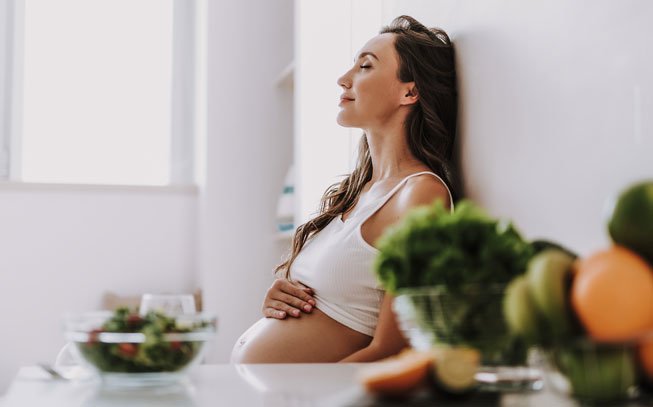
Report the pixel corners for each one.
[385,0,653,253]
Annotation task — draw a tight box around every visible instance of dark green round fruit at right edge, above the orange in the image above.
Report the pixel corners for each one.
[608,180,653,265]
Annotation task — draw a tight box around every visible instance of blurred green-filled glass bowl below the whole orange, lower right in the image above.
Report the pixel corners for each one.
[542,338,643,403]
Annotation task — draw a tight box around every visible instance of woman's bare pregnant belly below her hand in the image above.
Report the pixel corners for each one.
[231,309,372,363]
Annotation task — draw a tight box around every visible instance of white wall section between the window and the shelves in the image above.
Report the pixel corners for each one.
[199,0,293,362]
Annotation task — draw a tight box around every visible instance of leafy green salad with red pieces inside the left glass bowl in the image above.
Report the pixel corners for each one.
[77,308,212,373]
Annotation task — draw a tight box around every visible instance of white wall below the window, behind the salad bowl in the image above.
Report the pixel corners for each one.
[0,183,197,394]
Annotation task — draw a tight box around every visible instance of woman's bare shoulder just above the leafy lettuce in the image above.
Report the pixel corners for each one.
[396,174,451,213]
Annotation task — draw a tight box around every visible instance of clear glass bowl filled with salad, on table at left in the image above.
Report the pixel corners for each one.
[64,309,216,386]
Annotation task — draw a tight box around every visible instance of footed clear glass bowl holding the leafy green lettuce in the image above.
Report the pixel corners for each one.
[393,284,542,391]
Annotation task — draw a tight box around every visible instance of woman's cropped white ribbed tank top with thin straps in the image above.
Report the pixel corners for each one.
[290,171,453,336]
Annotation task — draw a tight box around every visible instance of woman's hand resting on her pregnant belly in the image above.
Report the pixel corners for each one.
[262,278,315,319]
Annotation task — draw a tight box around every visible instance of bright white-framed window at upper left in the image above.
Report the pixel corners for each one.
[0,0,201,185]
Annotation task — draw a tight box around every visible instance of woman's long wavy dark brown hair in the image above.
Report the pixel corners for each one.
[275,16,458,277]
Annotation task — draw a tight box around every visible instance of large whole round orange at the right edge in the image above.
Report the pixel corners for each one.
[571,246,653,342]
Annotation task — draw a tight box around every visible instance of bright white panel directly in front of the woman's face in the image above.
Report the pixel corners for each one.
[295,0,383,224]
